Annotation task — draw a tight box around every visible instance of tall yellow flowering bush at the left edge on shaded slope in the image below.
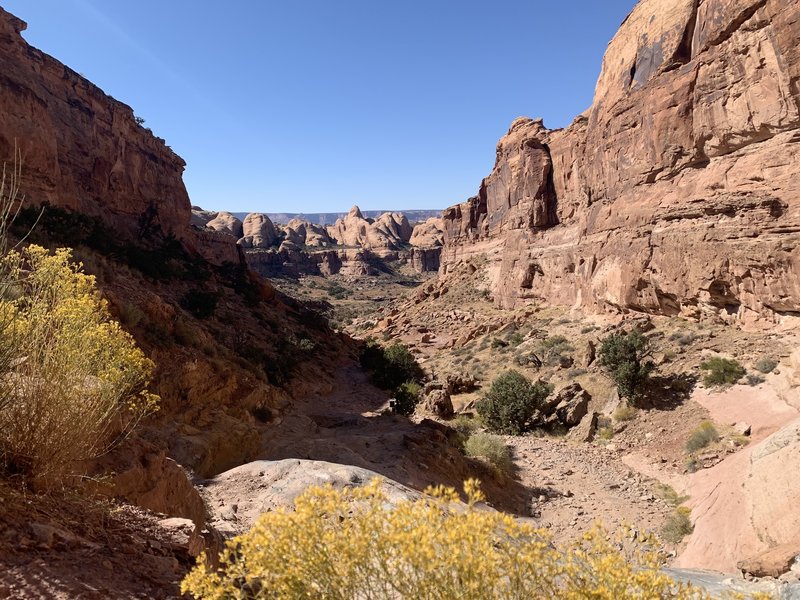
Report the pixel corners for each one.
[0,245,158,481]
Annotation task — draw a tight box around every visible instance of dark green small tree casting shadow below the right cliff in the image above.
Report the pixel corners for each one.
[600,330,656,404]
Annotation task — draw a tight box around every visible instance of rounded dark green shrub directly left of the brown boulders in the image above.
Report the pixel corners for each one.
[476,371,553,435]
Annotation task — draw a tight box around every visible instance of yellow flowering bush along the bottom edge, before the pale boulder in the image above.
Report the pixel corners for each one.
[181,480,706,600]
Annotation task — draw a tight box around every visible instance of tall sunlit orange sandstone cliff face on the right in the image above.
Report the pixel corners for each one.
[442,0,800,320]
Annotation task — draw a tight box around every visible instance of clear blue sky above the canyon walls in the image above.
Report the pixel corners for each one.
[0,0,635,212]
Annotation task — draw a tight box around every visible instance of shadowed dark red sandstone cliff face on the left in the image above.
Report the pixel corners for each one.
[0,9,190,239]
